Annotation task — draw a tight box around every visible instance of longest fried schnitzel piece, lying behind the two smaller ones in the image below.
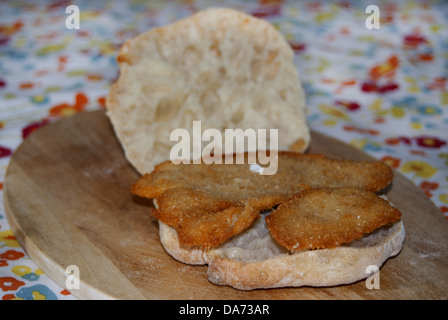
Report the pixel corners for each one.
[132,151,393,198]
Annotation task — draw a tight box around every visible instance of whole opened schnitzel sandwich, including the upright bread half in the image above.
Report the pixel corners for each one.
[106,8,404,290]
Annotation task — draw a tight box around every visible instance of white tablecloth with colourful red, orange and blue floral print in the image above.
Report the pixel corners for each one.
[0,0,448,300]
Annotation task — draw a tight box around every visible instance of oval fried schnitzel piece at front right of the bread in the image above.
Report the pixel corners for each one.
[265,188,401,250]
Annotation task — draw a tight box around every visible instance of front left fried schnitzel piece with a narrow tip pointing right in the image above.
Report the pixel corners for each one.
[153,188,274,247]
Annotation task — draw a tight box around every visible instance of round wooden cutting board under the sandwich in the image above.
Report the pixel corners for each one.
[4,110,448,299]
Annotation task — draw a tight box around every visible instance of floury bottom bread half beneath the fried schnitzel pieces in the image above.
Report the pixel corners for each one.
[159,220,405,290]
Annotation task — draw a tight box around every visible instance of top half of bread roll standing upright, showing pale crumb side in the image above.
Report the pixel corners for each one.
[107,8,310,174]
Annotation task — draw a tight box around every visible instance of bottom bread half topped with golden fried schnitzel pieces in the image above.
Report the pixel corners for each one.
[132,152,404,290]
